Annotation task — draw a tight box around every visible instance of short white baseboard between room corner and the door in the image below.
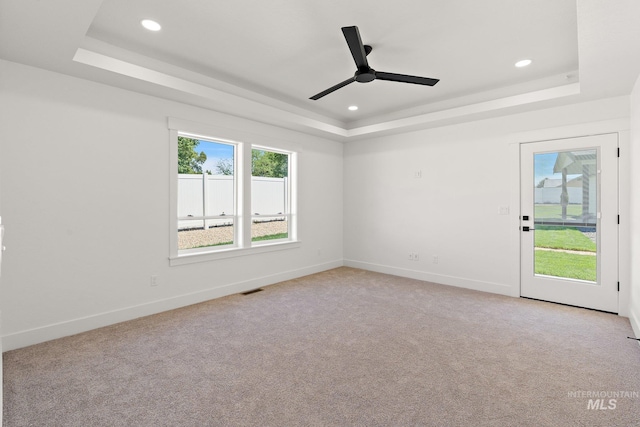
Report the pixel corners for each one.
[344,259,519,296]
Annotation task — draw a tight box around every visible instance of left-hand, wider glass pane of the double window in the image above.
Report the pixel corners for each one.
[177,135,236,250]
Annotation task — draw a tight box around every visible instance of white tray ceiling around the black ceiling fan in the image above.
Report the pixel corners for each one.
[0,0,640,140]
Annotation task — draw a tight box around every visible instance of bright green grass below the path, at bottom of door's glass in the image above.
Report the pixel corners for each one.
[535,250,596,282]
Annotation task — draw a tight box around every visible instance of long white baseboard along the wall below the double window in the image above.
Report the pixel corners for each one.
[2,260,343,351]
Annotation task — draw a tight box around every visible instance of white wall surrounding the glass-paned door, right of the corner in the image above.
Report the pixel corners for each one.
[344,97,629,304]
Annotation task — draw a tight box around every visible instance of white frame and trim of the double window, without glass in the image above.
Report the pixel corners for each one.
[168,117,301,266]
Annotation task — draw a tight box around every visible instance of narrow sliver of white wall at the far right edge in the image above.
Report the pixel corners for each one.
[629,77,640,338]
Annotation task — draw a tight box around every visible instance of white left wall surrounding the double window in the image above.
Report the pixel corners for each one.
[0,61,343,350]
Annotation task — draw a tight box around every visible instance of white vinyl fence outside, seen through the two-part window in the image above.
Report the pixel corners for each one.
[178,174,288,230]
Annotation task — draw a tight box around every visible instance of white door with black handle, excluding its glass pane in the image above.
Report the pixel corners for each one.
[520,133,619,313]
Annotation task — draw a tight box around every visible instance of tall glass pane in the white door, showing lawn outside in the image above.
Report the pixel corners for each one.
[534,149,598,282]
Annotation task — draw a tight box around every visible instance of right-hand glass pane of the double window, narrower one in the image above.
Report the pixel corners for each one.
[251,149,289,242]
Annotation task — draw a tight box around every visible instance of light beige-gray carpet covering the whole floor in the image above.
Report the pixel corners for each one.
[4,268,640,427]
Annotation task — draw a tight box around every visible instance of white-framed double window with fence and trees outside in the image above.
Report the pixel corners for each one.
[169,119,298,265]
